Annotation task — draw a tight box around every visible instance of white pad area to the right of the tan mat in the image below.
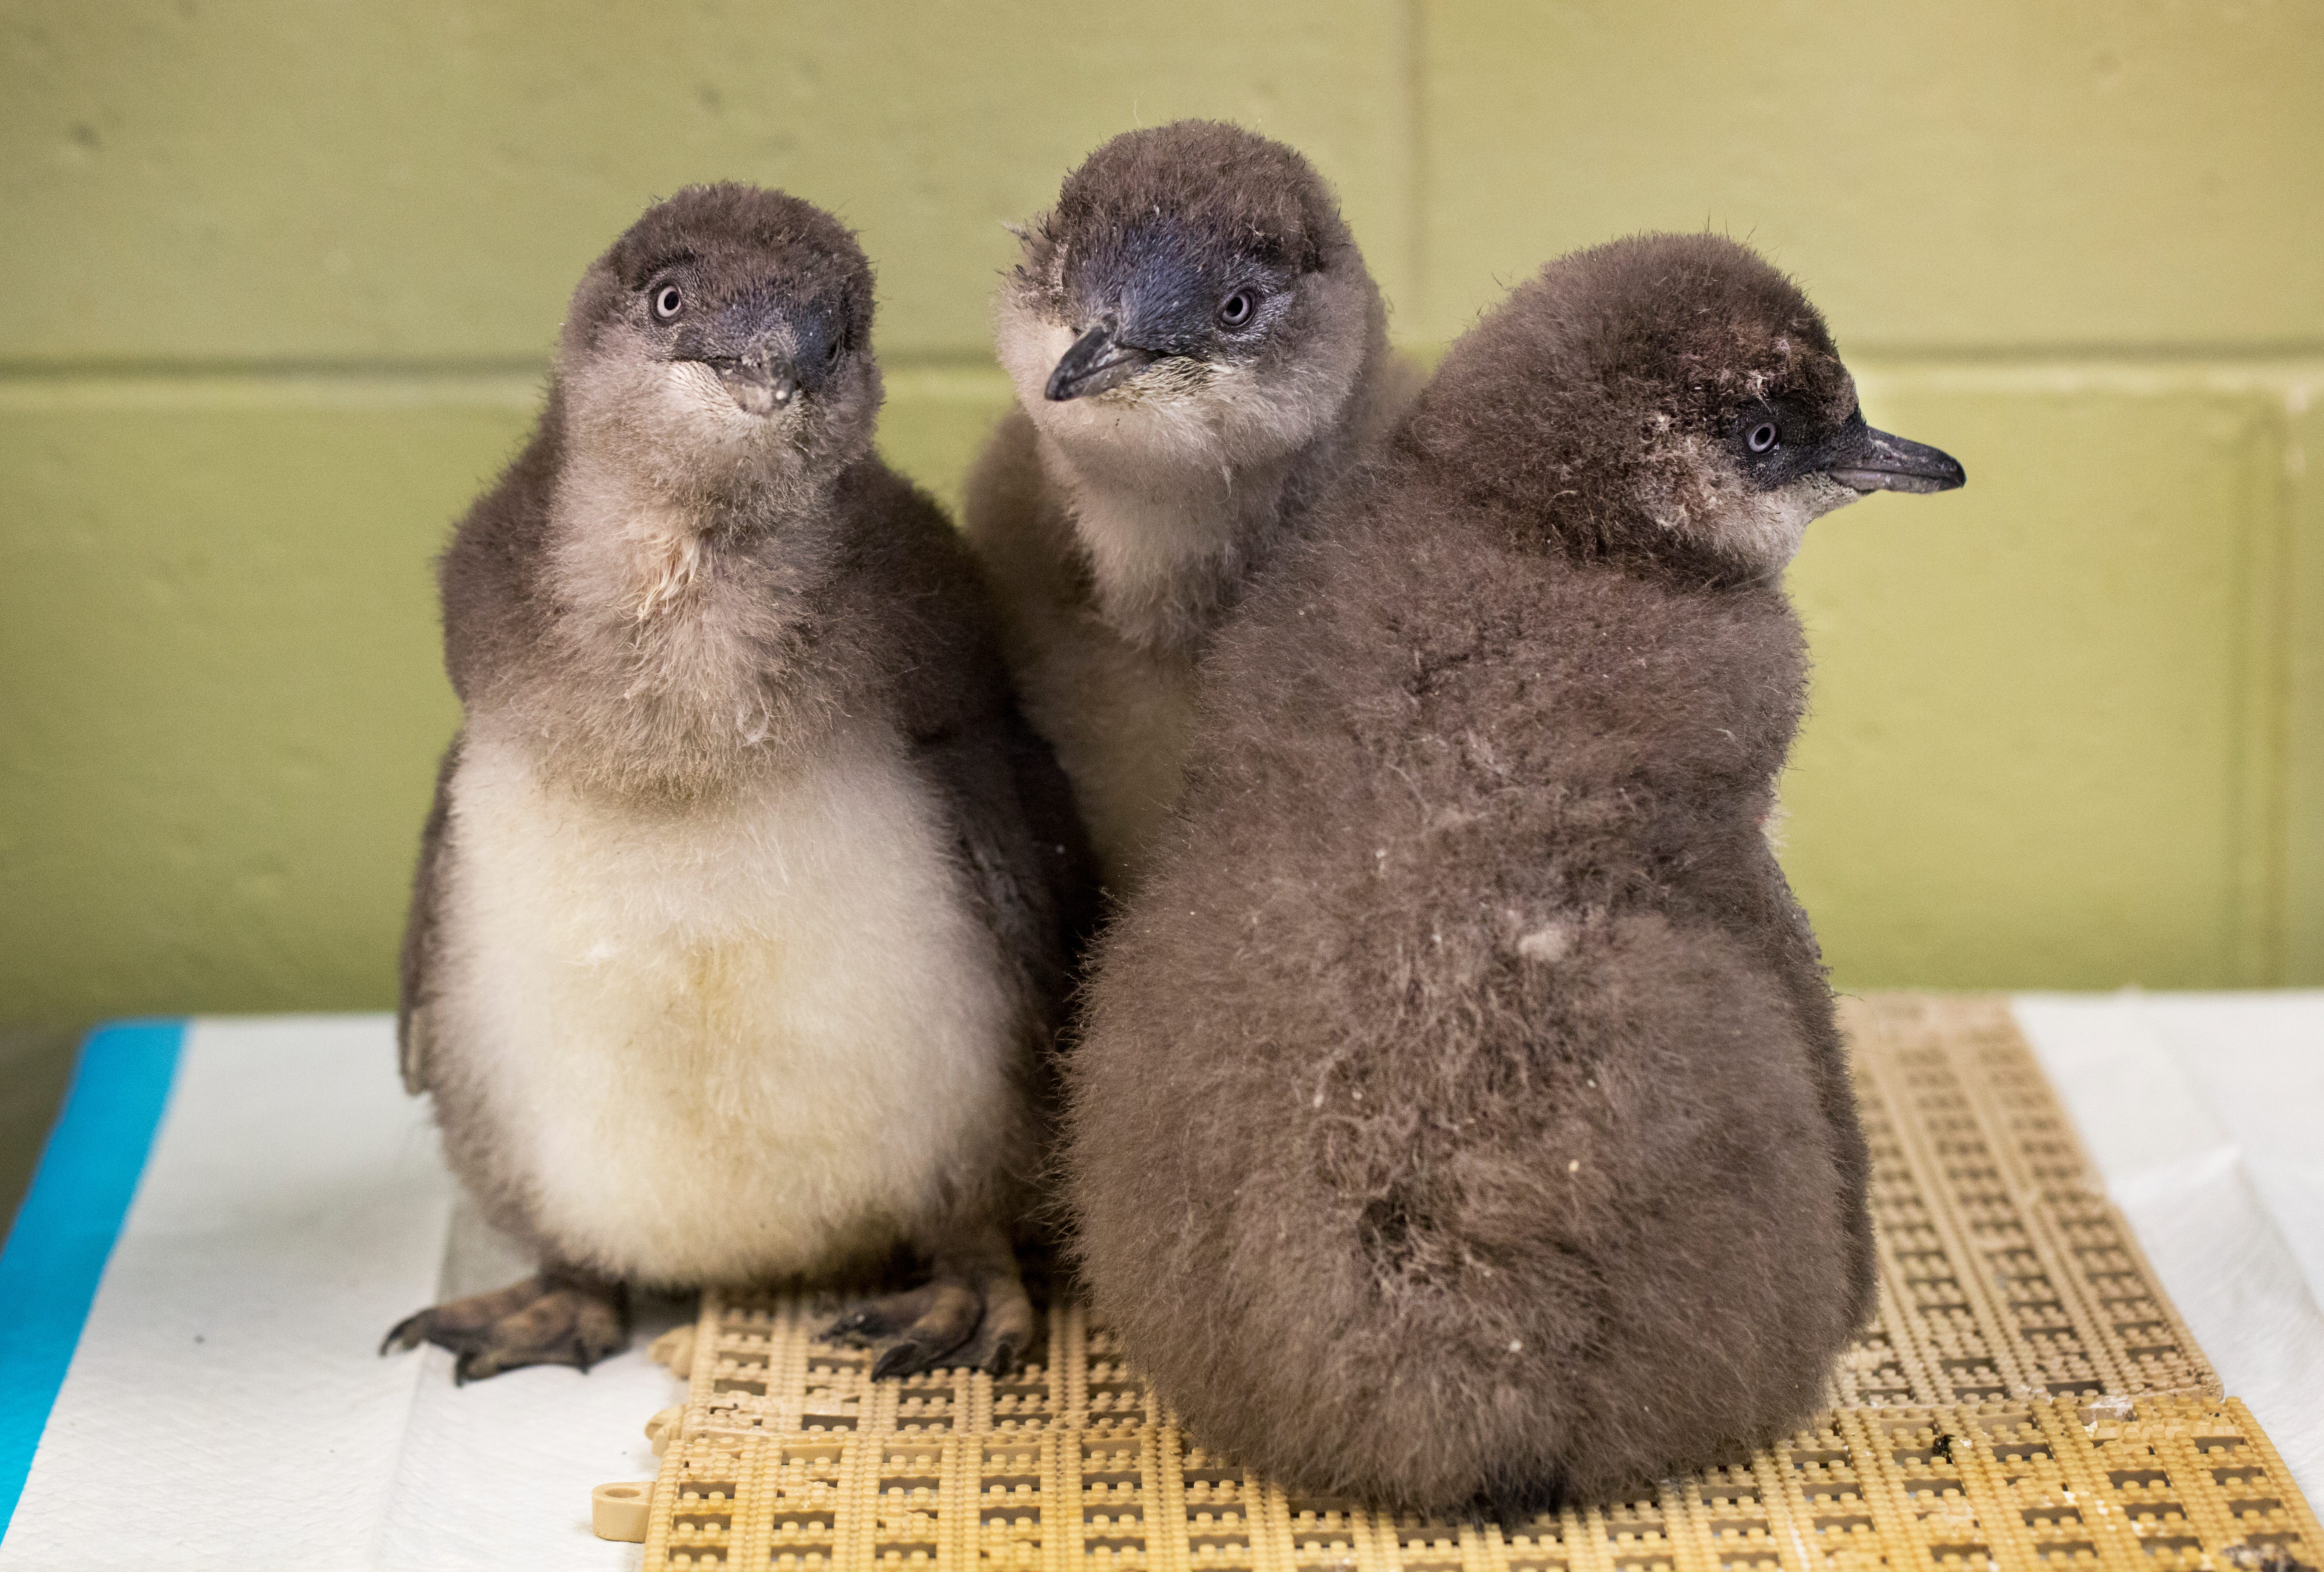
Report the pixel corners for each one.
[2015,993,2324,1502]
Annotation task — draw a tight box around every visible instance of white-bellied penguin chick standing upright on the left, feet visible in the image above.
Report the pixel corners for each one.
[388,186,1088,1379]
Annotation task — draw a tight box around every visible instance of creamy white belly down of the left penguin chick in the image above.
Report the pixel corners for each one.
[437,728,1020,1284]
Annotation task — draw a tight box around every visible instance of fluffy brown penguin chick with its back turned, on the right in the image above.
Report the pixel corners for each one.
[1067,237,1961,1509]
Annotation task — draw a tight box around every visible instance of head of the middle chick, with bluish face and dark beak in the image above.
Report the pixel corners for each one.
[995,121,1385,470]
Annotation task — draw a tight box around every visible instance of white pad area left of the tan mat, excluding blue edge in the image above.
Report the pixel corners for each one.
[0,1016,679,1572]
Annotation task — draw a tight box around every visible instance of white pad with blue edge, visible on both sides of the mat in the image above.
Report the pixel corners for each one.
[0,993,2324,1572]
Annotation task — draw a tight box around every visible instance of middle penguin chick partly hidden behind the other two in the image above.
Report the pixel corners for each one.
[964,121,1418,888]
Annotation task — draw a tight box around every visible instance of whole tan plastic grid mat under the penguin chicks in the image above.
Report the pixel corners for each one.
[644,995,2324,1572]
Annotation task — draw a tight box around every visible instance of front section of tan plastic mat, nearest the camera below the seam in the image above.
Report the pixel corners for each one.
[644,1397,2319,1572]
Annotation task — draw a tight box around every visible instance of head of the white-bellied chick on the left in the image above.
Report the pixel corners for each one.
[558,184,881,498]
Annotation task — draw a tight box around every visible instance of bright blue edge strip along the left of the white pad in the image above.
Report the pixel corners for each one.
[0,1021,186,1535]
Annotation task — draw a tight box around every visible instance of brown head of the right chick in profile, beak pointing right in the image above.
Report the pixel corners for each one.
[1404,235,1966,579]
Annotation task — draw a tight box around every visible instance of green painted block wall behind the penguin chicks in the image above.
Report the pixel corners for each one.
[0,0,2324,1026]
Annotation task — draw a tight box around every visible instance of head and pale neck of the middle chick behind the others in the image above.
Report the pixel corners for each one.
[995,121,1387,651]
